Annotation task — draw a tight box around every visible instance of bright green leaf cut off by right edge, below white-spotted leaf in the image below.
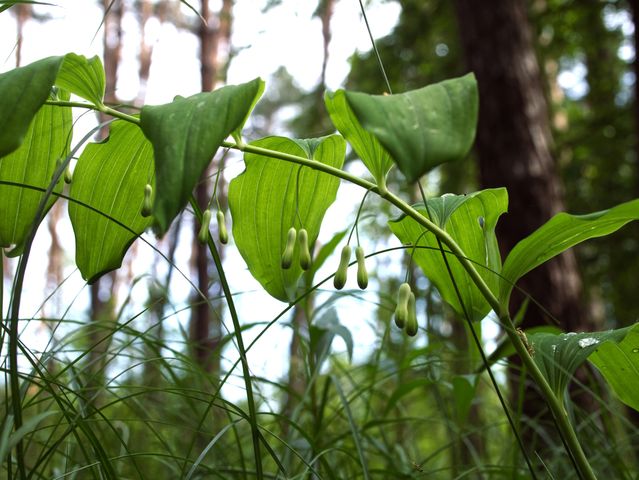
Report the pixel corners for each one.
[588,323,639,411]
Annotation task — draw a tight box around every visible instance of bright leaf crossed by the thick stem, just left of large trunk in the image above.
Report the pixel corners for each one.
[389,188,508,320]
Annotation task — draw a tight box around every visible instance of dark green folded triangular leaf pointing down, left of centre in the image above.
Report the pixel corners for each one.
[140,78,264,236]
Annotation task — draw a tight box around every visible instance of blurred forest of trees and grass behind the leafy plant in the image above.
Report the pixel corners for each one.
[1,0,639,478]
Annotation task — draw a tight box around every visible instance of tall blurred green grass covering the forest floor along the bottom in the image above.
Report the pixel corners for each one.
[0,253,639,479]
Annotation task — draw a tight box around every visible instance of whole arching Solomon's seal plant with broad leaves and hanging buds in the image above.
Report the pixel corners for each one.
[0,49,639,478]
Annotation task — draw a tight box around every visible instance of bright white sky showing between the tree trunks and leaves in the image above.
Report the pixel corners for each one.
[0,0,410,398]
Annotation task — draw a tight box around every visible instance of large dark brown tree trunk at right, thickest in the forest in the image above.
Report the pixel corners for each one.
[455,0,591,450]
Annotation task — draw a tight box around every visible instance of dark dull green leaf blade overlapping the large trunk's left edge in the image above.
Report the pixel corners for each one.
[345,73,479,182]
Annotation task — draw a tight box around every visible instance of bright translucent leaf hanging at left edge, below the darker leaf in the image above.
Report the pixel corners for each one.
[0,96,72,255]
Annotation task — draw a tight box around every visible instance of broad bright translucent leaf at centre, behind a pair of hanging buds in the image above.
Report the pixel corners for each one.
[229,135,346,302]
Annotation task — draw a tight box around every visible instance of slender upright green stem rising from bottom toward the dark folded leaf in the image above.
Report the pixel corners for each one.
[190,195,263,478]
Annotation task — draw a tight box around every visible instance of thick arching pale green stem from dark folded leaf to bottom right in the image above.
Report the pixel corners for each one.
[222,142,597,480]
